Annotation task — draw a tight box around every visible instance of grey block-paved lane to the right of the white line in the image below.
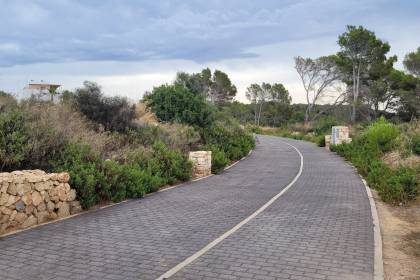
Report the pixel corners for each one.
[171,137,374,280]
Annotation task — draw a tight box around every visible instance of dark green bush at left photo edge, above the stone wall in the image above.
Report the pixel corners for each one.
[0,109,30,171]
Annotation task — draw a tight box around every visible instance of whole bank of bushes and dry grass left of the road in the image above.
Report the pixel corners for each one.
[0,73,254,208]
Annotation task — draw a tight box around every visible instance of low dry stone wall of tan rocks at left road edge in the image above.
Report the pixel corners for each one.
[0,170,82,234]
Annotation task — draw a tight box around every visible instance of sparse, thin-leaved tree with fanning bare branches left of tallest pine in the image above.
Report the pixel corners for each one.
[295,56,342,123]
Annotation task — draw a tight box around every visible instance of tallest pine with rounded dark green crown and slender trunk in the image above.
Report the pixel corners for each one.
[338,25,390,122]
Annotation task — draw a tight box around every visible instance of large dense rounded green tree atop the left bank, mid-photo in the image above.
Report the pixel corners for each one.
[143,84,213,127]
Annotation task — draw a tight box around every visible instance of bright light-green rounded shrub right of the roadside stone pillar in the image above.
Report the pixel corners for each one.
[361,117,400,153]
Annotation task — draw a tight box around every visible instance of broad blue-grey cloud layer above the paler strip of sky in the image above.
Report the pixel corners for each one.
[4,0,416,67]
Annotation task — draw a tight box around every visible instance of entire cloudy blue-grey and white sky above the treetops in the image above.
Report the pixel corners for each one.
[0,0,420,103]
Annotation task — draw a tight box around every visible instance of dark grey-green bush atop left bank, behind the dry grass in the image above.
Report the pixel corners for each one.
[74,81,136,132]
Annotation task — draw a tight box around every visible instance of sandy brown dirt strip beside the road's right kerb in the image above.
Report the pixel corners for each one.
[374,192,420,280]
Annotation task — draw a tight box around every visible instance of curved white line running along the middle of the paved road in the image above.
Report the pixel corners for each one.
[156,140,303,280]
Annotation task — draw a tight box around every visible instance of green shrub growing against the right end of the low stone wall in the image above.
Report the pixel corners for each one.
[54,144,106,208]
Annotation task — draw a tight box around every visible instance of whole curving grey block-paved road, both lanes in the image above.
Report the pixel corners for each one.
[0,136,374,280]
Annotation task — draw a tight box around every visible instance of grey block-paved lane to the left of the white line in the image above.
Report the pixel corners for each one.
[0,137,306,280]
